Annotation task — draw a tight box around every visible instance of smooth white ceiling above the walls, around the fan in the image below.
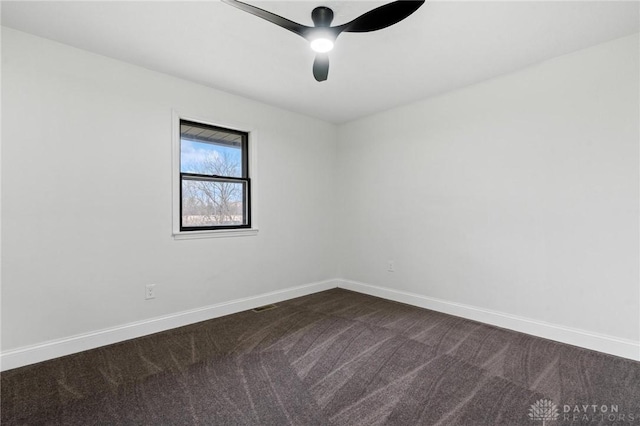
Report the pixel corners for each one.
[2,0,640,123]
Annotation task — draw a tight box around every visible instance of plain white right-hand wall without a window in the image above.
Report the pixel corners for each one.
[337,34,640,342]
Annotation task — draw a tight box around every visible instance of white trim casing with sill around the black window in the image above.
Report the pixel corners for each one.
[171,110,258,240]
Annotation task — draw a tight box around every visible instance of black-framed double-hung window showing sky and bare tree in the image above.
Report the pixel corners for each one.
[179,119,251,232]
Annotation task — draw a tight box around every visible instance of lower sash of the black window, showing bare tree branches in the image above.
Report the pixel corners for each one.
[182,179,247,227]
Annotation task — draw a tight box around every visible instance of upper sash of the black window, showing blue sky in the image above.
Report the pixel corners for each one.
[180,121,246,177]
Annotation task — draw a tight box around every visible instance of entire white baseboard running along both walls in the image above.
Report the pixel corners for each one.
[0,279,640,371]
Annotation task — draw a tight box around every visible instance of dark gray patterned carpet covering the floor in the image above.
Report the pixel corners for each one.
[0,289,640,426]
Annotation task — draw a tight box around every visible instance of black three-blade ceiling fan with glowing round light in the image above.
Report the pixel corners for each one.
[222,0,425,81]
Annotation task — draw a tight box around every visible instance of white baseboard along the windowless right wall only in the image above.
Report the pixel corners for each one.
[338,280,640,361]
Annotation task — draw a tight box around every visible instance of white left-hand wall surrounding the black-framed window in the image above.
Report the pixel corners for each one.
[2,29,337,350]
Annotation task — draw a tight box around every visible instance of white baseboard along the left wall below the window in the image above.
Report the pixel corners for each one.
[0,280,338,371]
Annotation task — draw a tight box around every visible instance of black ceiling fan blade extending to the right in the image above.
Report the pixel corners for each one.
[340,0,425,33]
